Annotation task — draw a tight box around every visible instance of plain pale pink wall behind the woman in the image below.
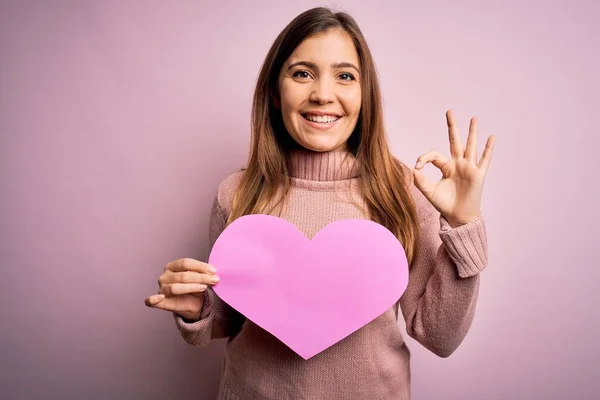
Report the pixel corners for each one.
[0,0,600,400]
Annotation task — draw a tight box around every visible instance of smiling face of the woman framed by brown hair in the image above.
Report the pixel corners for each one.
[278,30,361,152]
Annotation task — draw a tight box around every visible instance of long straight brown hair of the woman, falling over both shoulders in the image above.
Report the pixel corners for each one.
[228,7,419,263]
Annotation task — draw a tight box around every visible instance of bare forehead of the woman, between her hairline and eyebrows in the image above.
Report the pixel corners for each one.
[287,30,360,67]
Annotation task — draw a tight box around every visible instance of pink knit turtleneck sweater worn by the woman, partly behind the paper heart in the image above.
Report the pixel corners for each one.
[175,151,487,400]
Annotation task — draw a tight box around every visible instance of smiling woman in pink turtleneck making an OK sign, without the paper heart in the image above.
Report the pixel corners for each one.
[146,8,493,400]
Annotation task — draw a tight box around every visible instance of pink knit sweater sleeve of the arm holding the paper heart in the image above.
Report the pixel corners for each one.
[173,197,245,347]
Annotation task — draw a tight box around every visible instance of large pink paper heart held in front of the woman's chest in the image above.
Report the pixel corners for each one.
[208,214,408,359]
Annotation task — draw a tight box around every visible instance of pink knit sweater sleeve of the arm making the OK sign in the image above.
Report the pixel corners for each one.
[400,192,487,357]
